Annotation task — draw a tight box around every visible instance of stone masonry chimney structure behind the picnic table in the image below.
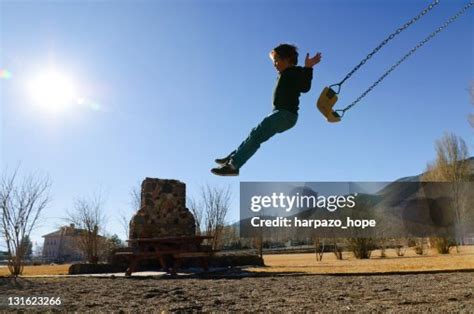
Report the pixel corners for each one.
[129,178,196,239]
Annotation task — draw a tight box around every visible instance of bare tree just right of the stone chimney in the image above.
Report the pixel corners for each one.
[201,185,231,249]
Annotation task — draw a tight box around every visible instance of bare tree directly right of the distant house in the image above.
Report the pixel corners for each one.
[66,194,105,263]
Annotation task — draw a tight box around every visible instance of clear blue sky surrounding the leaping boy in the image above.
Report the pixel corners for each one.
[0,0,474,245]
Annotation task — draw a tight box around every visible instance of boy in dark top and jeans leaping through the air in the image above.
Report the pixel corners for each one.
[211,44,321,176]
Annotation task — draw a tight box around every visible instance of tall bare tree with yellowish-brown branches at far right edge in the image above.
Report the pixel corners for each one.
[422,133,470,244]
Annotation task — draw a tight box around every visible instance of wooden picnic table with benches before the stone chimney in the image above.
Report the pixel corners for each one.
[115,236,214,276]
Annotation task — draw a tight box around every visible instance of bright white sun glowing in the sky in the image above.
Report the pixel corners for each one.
[29,69,76,111]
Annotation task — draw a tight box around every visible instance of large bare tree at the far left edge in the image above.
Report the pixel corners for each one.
[0,169,51,276]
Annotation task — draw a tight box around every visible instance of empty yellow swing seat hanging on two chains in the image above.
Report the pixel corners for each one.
[316,0,474,122]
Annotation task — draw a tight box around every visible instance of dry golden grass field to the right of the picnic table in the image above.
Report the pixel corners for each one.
[249,246,474,274]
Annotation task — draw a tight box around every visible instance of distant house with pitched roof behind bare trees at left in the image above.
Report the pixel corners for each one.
[43,224,85,263]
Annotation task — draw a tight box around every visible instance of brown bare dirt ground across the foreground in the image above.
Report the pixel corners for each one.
[0,271,474,312]
